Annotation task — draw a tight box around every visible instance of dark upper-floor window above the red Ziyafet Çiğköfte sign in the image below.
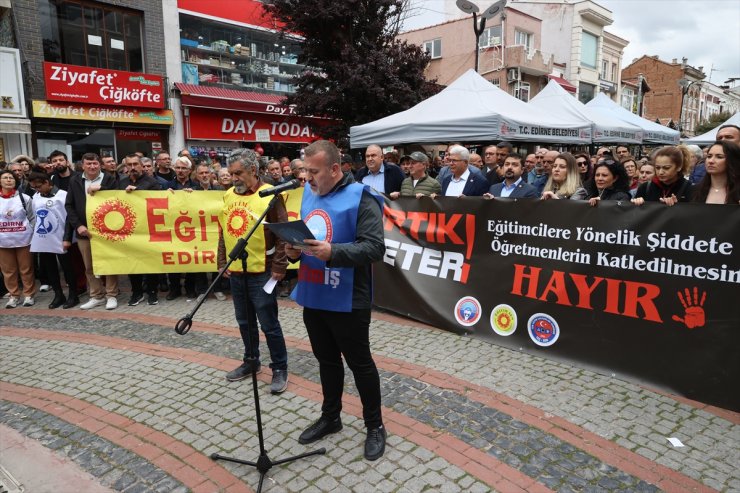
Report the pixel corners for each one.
[39,0,144,72]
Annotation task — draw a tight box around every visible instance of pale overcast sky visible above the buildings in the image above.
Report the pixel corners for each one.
[404,0,740,84]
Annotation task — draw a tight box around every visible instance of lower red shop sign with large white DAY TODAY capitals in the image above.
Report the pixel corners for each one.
[187,107,315,144]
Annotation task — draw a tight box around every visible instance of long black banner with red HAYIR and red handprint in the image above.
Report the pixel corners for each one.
[375,198,740,411]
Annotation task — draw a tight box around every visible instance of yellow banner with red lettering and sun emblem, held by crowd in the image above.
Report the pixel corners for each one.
[86,190,223,275]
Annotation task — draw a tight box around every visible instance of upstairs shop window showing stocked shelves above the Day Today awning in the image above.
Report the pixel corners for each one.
[180,15,304,93]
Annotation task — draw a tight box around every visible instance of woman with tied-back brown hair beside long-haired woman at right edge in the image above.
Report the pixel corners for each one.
[632,146,694,206]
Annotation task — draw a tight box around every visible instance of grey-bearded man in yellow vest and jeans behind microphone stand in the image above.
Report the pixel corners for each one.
[218,149,288,394]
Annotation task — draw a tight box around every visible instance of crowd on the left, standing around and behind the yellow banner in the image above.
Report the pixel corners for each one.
[0,146,306,310]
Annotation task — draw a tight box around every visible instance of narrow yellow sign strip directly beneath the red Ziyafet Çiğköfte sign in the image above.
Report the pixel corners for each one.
[33,100,173,125]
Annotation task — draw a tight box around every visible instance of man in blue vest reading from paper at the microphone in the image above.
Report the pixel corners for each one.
[286,140,386,460]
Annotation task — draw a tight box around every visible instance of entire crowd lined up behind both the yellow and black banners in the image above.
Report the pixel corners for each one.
[0,125,740,310]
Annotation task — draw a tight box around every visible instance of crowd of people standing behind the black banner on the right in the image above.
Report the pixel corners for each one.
[354,125,740,206]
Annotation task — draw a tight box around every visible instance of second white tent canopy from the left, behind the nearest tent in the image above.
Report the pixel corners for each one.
[529,80,642,144]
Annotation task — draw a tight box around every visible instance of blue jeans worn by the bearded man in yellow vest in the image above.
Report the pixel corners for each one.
[230,272,288,370]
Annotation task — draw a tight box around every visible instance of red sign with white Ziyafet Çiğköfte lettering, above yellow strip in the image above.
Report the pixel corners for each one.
[44,62,165,108]
